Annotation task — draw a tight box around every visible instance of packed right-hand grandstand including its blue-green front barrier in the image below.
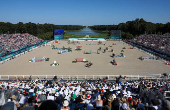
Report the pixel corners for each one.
[128,33,170,61]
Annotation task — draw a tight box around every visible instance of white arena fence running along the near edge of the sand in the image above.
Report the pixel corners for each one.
[0,74,164,80]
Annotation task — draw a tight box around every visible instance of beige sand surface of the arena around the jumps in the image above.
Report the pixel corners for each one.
[0,41,170,75]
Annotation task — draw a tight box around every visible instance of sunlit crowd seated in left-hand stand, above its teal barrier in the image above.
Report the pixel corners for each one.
[0,33,43,57]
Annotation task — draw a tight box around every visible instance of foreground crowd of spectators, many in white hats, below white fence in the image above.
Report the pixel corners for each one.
[0,79,170,110]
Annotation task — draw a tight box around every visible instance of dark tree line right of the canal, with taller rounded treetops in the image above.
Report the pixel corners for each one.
[90,18,170,39]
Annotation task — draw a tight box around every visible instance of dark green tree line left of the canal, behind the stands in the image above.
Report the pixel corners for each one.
[0,22,84,40]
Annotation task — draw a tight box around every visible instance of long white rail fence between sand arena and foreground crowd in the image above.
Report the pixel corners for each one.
[0,74,161,80]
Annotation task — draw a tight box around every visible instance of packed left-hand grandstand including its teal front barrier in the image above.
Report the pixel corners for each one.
[0,33,45,61]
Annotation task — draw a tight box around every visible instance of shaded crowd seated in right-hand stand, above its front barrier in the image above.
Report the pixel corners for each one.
[132,33,170,54]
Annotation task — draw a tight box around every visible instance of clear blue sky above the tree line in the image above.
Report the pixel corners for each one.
[0,0,170,25]
